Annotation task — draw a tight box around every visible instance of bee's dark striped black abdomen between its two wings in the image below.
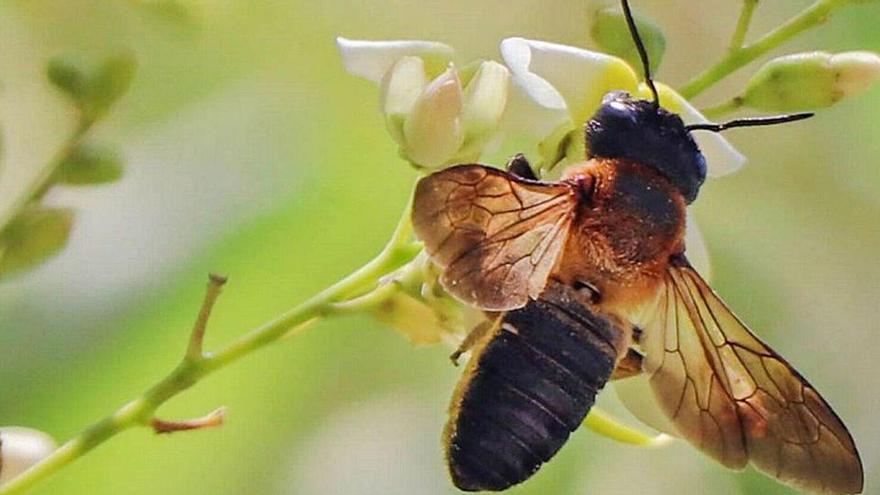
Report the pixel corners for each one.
[446,284,622,491]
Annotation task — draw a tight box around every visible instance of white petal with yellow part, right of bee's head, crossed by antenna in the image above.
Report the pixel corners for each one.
[639,83,746,177]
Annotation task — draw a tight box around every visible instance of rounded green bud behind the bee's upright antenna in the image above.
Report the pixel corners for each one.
[590,7,666,71]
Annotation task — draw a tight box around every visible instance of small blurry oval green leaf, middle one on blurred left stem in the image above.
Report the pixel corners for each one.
[53,144,123,186]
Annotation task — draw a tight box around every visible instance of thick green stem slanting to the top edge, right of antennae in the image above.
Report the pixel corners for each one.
[679,0,844,100]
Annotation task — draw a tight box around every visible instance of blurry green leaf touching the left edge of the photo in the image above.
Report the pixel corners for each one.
[0,205,74,278]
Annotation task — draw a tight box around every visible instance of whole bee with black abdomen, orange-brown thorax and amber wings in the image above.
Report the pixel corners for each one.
[412,0,864,493]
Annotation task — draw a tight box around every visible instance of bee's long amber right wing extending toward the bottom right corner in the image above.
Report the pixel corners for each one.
[641,257,863,494]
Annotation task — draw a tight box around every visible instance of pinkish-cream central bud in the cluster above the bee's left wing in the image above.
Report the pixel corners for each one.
[401,65,464,168]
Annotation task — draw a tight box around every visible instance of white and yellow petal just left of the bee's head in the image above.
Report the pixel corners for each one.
[501,38,638,125]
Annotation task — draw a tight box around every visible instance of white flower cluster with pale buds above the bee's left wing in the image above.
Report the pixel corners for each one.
[337,38,510,168]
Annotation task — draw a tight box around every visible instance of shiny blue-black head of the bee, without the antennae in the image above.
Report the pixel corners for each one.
[586,91,706,203]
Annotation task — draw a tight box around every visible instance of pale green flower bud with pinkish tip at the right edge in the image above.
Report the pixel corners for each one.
[740,51,880,112]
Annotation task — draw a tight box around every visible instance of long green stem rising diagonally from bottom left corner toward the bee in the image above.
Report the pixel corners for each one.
[0,192,421,495]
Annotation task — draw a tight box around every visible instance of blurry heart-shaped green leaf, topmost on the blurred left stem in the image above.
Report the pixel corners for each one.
[47,53,137,120]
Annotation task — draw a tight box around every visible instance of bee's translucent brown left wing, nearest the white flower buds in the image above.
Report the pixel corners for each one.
[413,165,577,311]
